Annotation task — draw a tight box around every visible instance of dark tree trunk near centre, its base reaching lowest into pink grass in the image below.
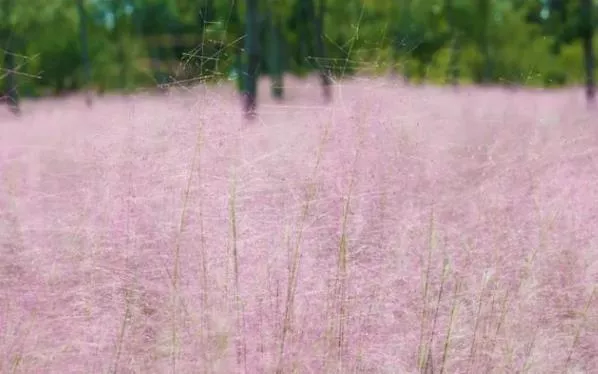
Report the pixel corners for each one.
[244,0,260,118]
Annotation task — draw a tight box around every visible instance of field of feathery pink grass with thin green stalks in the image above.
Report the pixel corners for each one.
[0,79,598,373]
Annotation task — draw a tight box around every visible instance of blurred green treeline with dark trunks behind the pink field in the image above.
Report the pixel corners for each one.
[0,0,596,109]
